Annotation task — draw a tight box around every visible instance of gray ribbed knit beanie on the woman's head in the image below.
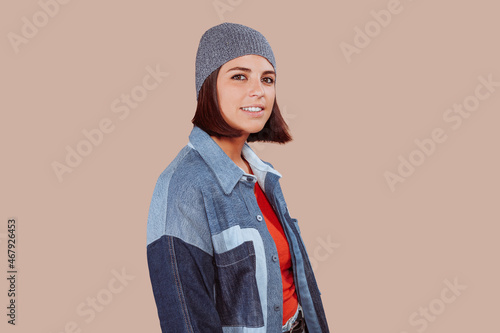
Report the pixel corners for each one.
[196,22,276,100]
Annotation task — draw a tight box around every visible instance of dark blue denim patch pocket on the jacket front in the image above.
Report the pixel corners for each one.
[214,241,264,327]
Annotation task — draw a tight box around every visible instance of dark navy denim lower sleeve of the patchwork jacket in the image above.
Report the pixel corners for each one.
[147,235,222,333]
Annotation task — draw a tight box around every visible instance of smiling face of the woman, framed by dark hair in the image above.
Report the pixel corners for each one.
[217,54,276,135]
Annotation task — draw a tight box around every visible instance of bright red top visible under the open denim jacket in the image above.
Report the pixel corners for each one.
[250,168,298,325]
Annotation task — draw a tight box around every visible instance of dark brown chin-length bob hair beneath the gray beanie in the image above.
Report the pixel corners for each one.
[191,66,292,144]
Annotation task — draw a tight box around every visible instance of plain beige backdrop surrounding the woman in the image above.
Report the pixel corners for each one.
[0,0,500,333]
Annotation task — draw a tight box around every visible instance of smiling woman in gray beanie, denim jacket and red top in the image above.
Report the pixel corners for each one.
[147,23,329,333]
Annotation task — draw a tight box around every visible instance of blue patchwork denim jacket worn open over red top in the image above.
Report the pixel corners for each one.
[147,126,329,333]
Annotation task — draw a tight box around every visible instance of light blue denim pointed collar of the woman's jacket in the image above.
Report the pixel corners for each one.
[188,125,281,194]
